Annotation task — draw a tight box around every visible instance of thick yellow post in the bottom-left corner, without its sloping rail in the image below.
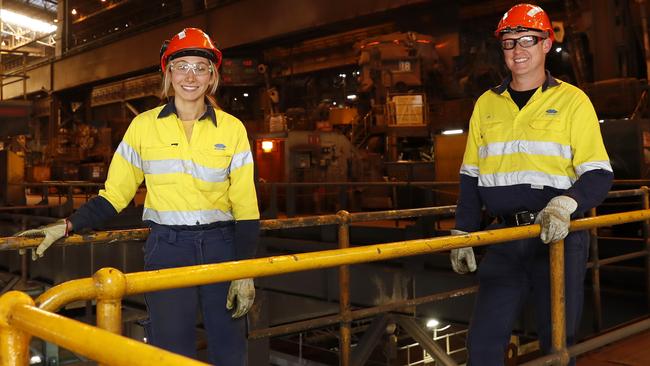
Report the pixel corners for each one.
[0,291,34,366]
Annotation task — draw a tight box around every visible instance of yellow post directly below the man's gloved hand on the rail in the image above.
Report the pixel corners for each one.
[550,240,569,365]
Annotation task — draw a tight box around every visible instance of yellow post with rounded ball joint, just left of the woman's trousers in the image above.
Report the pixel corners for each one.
[93,268,126,334]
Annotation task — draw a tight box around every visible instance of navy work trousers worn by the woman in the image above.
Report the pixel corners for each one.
[144,224,247,366]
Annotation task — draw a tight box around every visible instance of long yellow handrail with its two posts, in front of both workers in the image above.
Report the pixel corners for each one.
[3,210,650,363]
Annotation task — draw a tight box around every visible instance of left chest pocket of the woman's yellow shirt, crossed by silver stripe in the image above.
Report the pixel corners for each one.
[142,146,183,186]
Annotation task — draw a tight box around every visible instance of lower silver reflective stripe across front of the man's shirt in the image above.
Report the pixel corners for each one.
[478,171,575,189]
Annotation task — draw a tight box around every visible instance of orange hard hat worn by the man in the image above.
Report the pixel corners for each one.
[494,4,555,41]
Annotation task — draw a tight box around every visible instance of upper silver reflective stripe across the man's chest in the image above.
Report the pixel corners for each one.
[478,140,573,159]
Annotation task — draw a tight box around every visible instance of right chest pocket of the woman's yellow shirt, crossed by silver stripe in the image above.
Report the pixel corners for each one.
[191,149,233,191]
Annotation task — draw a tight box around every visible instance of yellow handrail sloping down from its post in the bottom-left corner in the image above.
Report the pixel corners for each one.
[0,291,207,366]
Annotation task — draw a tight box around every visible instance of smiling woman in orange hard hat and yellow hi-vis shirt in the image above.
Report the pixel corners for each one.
[19,28,259,366]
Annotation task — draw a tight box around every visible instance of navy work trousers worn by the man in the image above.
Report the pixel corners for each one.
[467,227,589,366]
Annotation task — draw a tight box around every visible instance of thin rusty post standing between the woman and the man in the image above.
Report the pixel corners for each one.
[337,210,352,366]
